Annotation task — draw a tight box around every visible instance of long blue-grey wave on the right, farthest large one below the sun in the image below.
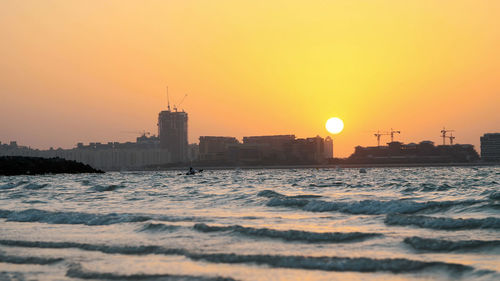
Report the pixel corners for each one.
[267,197,482,215]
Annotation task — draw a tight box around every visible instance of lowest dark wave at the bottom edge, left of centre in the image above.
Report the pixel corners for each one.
[66,264,234,281]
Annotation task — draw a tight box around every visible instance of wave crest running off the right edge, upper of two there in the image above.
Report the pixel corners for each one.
[384,214,500,230]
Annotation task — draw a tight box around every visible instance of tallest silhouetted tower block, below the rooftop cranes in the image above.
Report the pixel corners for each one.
[158,110,188,162]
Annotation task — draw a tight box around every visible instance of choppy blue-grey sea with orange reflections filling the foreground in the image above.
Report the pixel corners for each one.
[0,167,500,281]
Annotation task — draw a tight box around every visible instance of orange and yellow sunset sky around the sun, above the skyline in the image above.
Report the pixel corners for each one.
[0,0,500,157]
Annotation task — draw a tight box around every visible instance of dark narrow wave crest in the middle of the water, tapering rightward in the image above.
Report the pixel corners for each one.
[194,223,382,243]
